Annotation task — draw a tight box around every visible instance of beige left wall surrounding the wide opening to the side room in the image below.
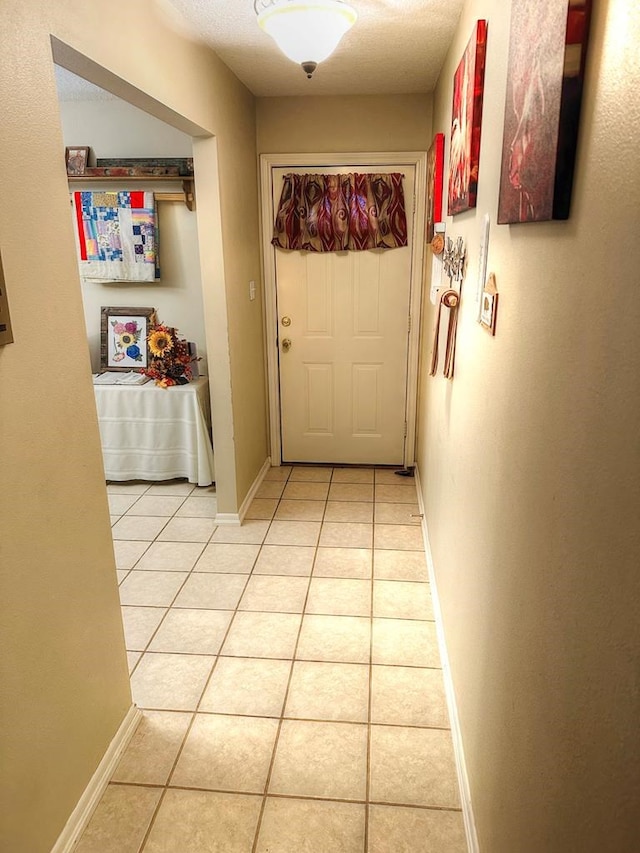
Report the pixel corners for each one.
[0,0,266,853]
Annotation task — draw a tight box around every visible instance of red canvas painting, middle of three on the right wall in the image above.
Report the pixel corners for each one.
[448,21,487,216]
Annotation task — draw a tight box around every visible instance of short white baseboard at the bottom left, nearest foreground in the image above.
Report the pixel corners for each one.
[51,705,142,853]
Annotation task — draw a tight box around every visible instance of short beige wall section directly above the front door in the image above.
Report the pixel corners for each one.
[256,95,432,154]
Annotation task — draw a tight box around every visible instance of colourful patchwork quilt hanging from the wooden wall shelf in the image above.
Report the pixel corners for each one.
[73,192,160,281]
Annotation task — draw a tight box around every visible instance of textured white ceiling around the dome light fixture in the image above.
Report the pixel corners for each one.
[58,0,464,100]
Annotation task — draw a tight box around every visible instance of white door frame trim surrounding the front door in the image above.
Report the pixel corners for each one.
[260,151,427,468]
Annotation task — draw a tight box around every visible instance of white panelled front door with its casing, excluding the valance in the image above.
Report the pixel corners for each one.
[261,152,426,466]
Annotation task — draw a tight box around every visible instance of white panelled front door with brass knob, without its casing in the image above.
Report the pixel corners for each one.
[272,166,415,465]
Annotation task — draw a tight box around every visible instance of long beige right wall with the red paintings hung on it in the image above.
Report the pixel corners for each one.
[418,0,640,853]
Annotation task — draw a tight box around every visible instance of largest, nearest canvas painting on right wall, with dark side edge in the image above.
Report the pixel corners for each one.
[498,0,591,224]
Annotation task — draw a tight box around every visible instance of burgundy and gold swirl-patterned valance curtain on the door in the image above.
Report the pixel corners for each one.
[271,172,407,252]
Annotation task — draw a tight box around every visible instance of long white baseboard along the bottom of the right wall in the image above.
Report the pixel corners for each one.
[414,466,480,853]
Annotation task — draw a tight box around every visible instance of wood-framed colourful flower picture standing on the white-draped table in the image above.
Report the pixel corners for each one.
[100,307,156,370]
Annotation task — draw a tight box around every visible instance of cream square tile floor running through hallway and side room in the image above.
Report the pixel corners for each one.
[77,466,467,853]
